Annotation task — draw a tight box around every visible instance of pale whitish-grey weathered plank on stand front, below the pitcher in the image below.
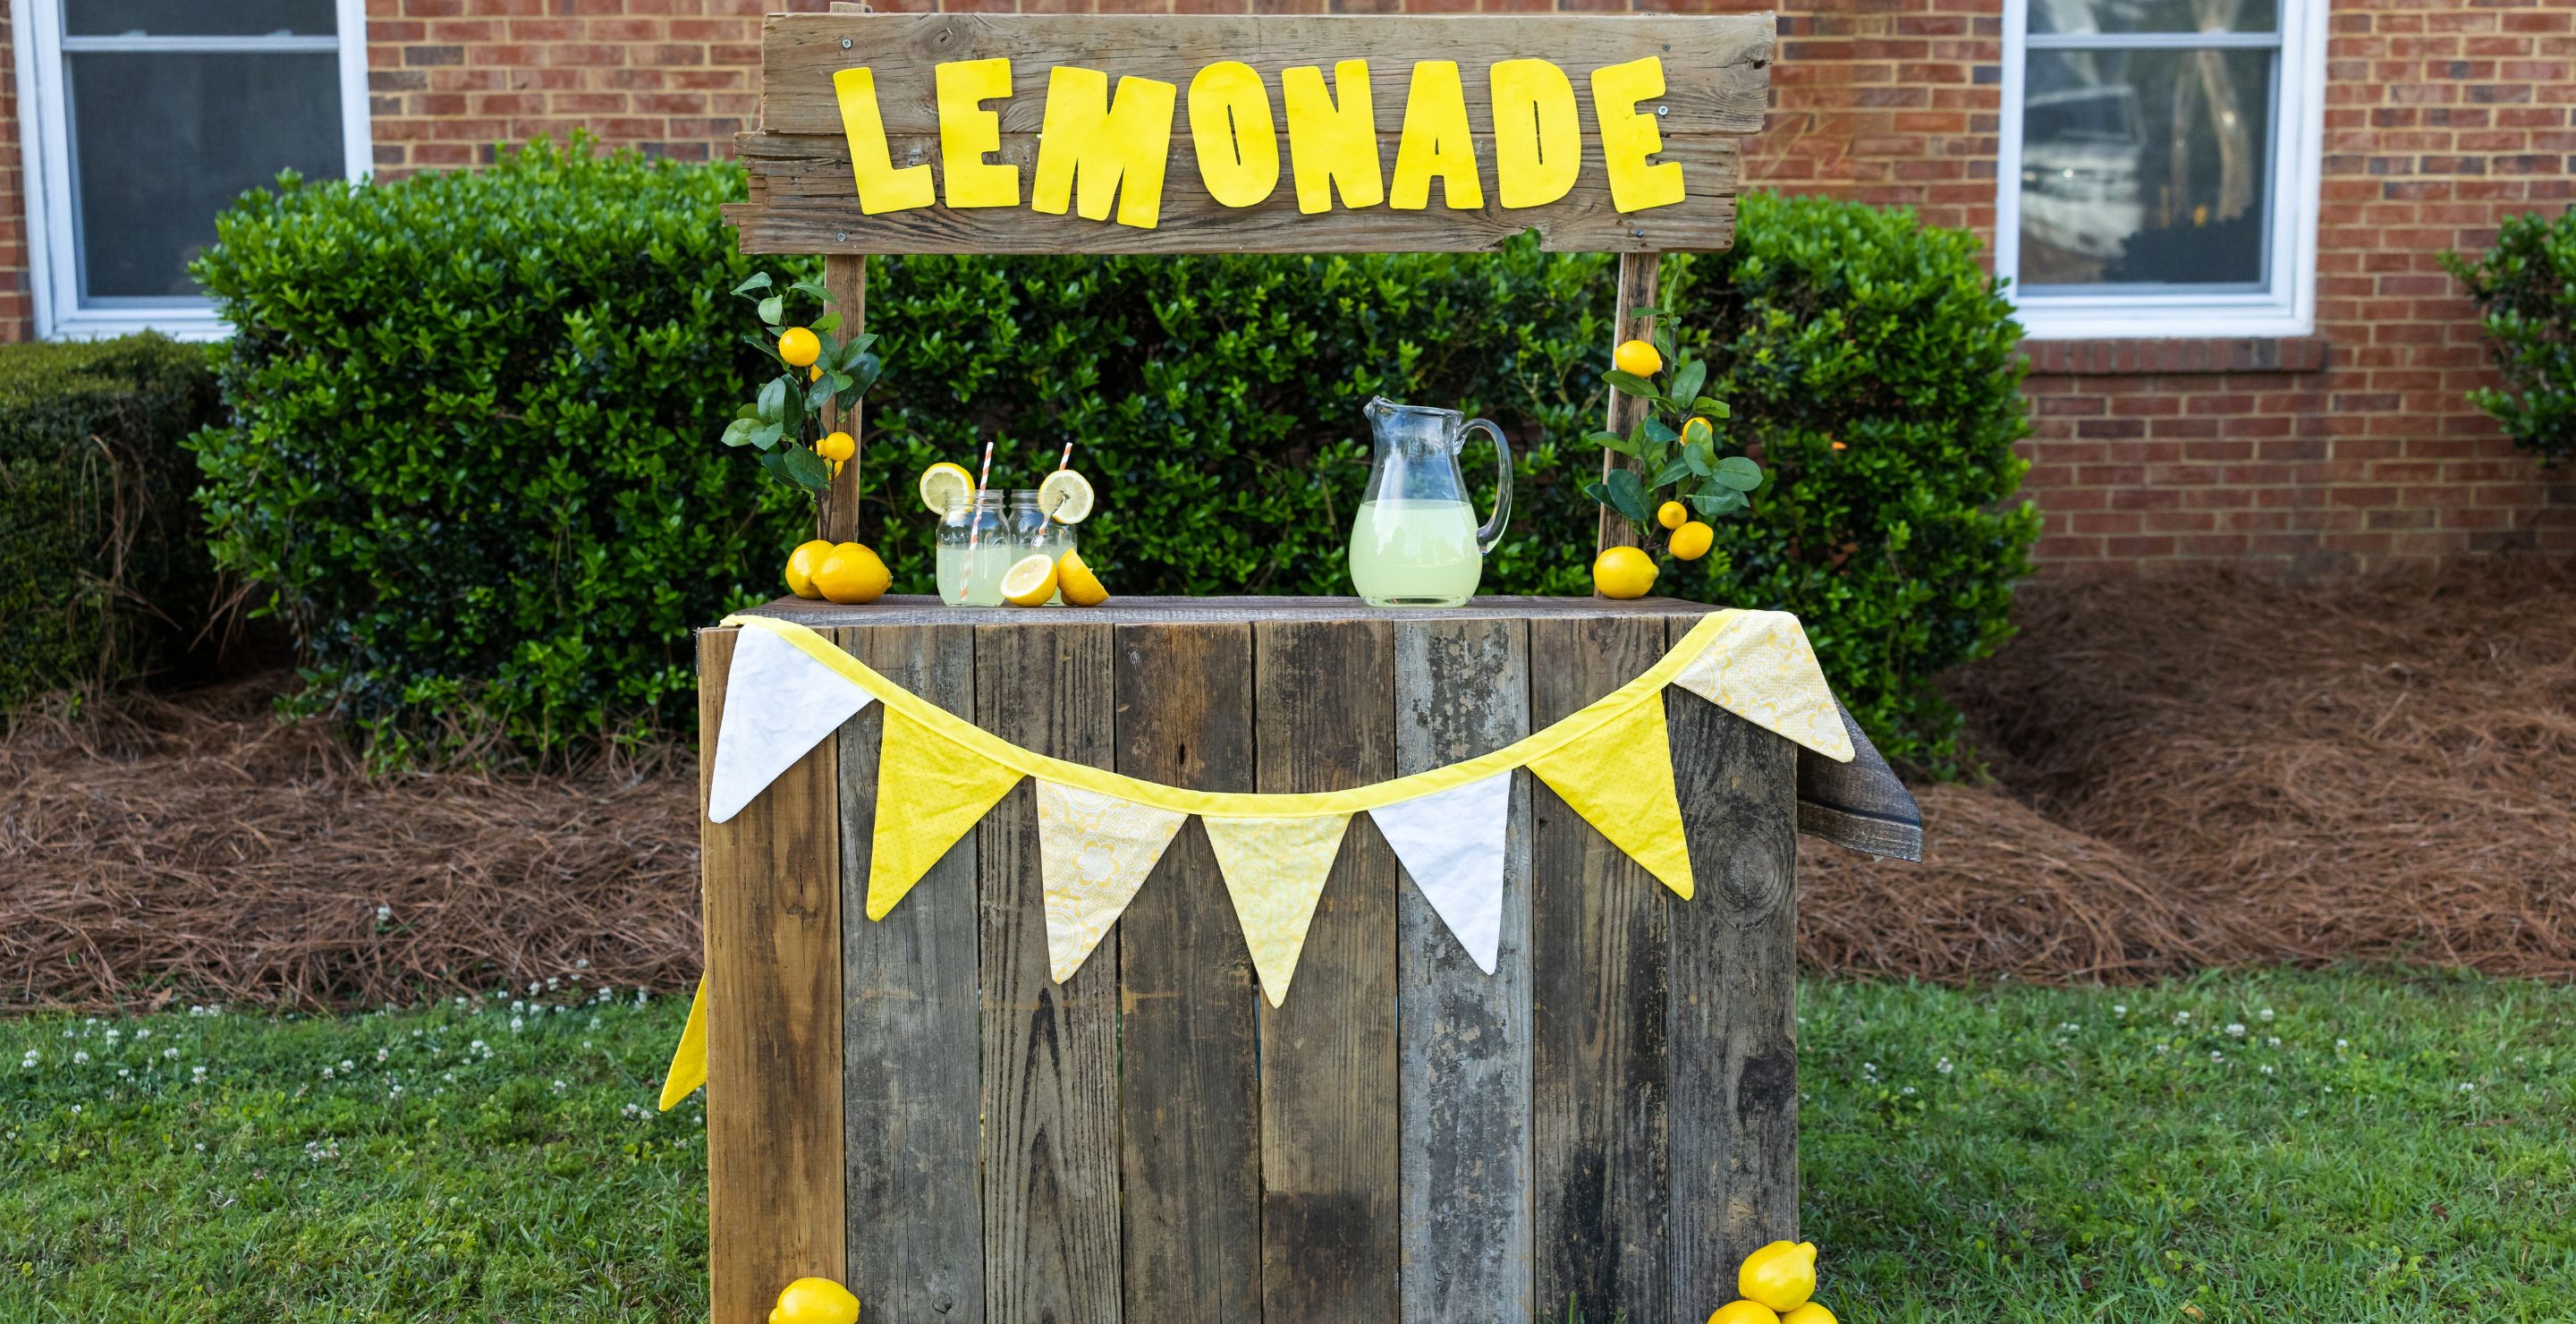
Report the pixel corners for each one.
[1396,618,1533,1324]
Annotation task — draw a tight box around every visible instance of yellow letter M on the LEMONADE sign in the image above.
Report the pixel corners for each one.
[1030,64,1180,229]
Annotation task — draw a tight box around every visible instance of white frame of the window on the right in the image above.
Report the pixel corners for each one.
[1994,0,2329,340]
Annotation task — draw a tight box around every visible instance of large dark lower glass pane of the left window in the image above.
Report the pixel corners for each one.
[64,52,348,299]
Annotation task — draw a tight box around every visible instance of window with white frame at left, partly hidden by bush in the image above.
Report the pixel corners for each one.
[11,0,374,337]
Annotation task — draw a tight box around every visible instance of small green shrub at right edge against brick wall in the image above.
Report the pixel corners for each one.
[2442,211,2576,463]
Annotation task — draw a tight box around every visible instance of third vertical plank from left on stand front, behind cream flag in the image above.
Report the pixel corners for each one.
[955,618,1121,1324]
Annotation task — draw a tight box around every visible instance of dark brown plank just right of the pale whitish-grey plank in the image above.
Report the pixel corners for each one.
[1530,618,1669,1324]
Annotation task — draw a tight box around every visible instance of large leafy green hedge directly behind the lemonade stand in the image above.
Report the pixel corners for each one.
[199,144,2035,770]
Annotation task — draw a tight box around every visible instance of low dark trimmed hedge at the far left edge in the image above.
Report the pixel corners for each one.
[0,335,222,709]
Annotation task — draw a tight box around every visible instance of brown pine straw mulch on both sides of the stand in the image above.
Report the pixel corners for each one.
[0,562,2576,1007]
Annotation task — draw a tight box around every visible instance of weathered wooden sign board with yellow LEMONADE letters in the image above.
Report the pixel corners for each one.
[726,13,1772,252]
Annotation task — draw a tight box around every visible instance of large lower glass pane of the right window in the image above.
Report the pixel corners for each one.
[2020,52,2272,286]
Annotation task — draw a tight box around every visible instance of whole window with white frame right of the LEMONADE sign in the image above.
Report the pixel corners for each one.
[1994,0,2326,337]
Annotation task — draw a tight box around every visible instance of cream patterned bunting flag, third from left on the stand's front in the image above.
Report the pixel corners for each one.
[1038,778,1191,984]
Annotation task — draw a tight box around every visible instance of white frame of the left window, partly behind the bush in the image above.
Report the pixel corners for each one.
[8,0,376,340]
